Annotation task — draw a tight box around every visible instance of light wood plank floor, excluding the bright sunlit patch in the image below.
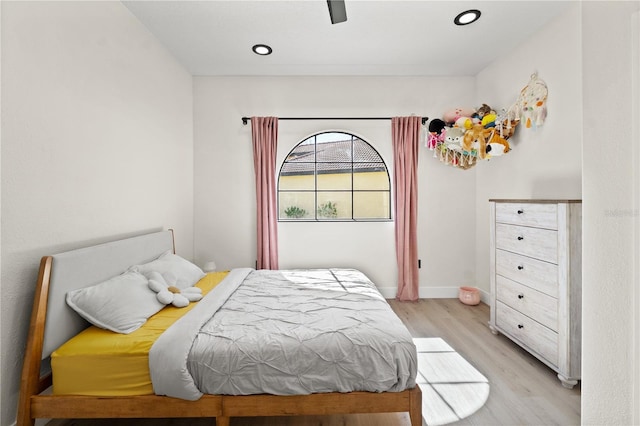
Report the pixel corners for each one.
[49,299,580,426]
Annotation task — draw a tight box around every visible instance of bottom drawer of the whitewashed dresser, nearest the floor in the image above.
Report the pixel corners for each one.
[496,301,558,366]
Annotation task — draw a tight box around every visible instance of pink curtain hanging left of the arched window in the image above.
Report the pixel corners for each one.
[251,117,278,269]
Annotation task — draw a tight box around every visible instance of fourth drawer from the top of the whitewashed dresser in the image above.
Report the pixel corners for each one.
[496,276,558,332]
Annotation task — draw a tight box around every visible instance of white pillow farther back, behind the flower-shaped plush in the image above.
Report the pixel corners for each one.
[129,251,206,289]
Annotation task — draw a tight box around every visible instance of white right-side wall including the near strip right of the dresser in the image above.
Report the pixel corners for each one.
[476,1,640,425]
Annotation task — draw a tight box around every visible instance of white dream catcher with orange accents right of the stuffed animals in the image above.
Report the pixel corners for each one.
[507,73,549,129]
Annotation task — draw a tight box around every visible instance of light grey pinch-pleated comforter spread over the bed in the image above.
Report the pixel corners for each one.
[149,269,417,400]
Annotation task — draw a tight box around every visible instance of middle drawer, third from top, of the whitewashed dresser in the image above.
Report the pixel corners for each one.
[496,250,558,298]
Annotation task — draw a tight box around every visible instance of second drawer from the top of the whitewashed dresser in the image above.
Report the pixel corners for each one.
[496,223,558,263]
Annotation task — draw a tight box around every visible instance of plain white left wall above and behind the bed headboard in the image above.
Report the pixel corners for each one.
[0,1,193,425]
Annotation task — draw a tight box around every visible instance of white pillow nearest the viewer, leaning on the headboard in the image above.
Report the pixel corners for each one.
[67,271,165,334]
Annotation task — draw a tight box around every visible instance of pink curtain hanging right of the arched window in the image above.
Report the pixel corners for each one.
[391,117,421,301]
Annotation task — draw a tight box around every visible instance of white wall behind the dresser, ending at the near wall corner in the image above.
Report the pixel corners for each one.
[476,3,582,291]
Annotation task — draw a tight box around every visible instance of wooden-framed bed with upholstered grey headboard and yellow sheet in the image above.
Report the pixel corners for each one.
[17,231,422,426]
